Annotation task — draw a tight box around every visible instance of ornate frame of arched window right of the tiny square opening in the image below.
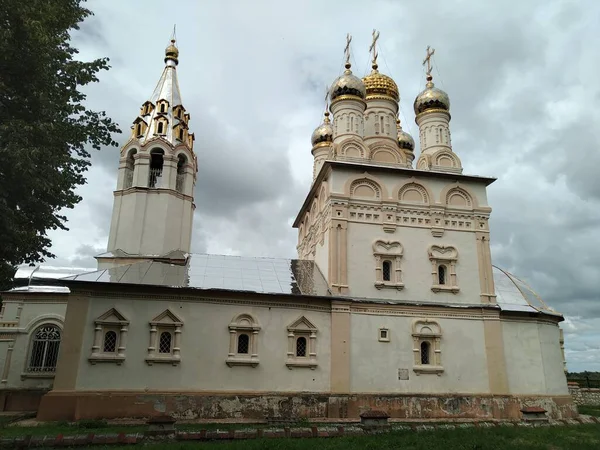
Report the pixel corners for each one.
[412,319,444,376]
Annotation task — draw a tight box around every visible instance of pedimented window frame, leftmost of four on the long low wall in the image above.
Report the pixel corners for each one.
[88,308,129,366]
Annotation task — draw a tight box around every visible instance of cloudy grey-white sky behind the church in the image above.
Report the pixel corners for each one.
[51,0,600,371]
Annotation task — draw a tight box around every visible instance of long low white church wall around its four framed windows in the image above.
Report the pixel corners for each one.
[77,298,331,392]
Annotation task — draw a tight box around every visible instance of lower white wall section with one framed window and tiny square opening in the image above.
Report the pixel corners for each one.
[350,314,489,393]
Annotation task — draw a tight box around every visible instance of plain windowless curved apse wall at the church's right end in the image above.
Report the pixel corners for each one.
[502,320,568,395]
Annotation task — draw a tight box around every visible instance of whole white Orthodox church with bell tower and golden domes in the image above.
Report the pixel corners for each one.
[0,34,577,420]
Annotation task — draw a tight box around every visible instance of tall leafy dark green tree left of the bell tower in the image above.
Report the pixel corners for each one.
[0,0,120,289]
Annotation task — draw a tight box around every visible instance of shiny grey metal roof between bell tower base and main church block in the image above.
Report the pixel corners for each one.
[64,254,331,296]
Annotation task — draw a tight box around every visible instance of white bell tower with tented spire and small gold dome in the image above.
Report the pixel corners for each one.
[96,39,198,268]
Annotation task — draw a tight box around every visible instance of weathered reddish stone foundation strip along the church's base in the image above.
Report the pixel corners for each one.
[37,391,577,421]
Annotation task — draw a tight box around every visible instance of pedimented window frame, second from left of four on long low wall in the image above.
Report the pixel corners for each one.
[146,309,183,366]
